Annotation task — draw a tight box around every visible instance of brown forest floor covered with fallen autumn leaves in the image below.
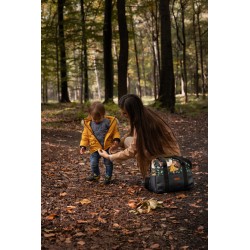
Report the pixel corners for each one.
[41,103,208,250]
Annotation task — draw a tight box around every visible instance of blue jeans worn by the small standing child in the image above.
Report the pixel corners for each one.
[90,150,113,177]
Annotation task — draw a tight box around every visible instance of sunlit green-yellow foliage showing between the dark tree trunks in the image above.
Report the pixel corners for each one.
[41,0,208,102]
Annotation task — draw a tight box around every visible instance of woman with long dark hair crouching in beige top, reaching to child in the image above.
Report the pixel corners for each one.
[98,94,181,178]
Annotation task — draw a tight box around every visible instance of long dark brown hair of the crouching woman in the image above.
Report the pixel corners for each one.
[119,94,179,176]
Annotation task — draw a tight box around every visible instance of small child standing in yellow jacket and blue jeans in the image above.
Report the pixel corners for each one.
[80,102,120,184]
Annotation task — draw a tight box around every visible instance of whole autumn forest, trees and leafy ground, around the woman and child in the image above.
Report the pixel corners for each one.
[42,0,208,250]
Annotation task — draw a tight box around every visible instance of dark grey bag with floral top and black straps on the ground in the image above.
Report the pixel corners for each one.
[145,156,194,194]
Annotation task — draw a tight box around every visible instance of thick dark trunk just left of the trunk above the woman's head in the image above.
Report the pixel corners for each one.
[103,0,114,102]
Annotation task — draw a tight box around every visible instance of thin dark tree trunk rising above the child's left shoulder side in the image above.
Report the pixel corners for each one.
[80,0,89,103]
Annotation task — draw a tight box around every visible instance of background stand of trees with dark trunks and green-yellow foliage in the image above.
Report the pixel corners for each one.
[41,0,208,111]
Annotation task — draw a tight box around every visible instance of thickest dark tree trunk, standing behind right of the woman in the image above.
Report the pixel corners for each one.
[159,0,175,112]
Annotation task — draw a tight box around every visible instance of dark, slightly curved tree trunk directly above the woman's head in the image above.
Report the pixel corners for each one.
[117,0,129,100]
